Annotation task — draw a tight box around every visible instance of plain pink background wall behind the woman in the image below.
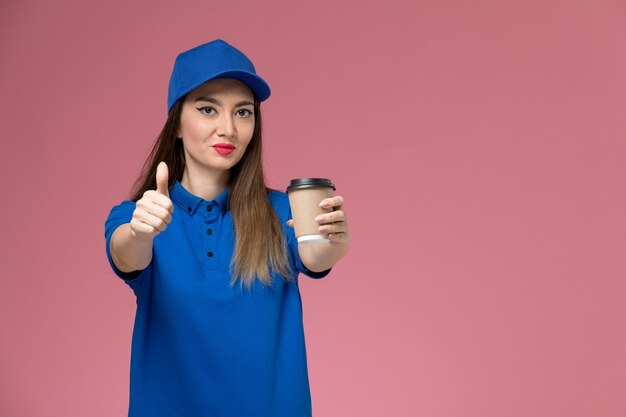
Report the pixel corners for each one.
[0,0,626,417]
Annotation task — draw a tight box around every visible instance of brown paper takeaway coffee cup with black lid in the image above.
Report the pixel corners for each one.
[287,178,335,243]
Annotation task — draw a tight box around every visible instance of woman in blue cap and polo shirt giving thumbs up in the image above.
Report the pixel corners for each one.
[105,39,350,417]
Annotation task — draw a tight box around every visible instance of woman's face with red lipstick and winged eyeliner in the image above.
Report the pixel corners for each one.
[178,78,255,176]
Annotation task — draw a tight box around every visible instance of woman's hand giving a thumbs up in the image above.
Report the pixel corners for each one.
[130,162,174,240]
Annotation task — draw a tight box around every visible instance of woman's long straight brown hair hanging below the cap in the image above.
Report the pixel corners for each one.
[131,96,293,290]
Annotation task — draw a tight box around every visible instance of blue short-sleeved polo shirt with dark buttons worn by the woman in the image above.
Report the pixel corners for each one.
[105,181,331,417]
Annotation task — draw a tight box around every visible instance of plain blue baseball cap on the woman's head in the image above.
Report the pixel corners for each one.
[167,39,271,114]
